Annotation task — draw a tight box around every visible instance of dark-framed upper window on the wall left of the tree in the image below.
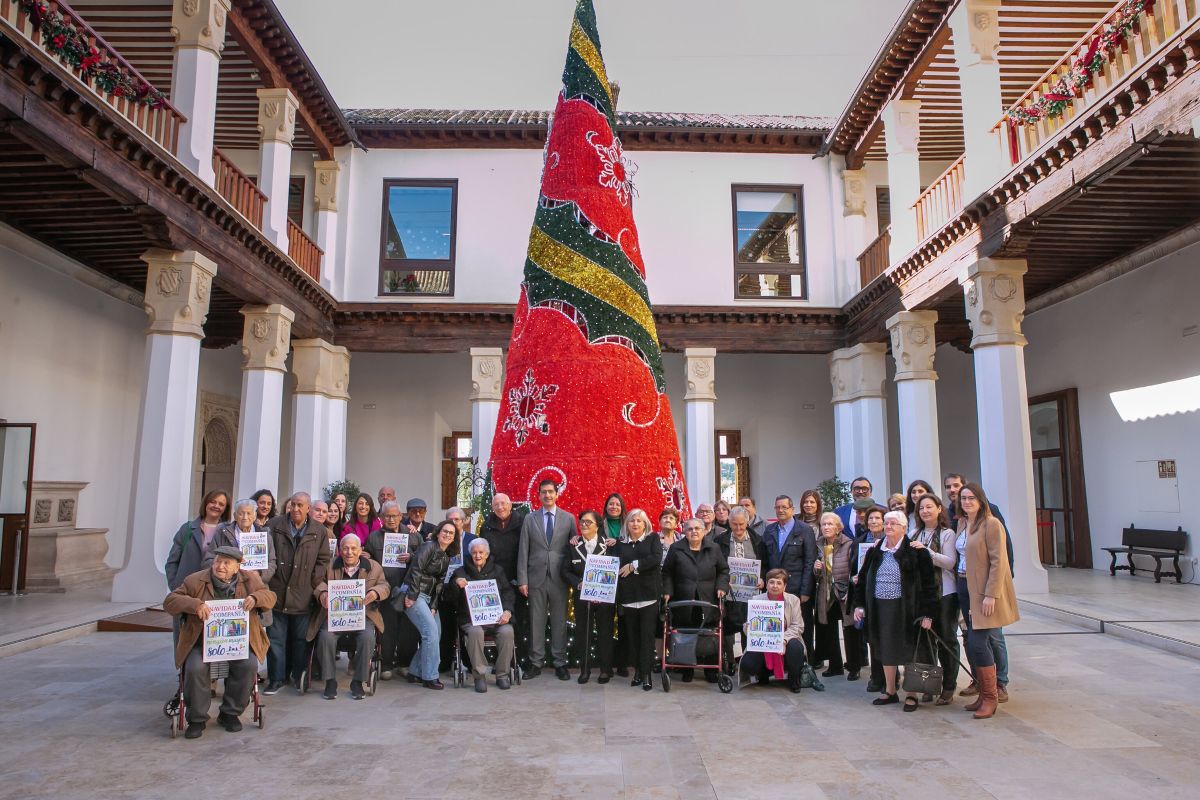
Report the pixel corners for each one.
[379,180,458,295]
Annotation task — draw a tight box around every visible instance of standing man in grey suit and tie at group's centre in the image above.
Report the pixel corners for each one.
[517,479,578,680]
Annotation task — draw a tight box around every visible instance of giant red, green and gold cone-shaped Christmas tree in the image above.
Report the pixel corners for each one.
[491,0,691,525]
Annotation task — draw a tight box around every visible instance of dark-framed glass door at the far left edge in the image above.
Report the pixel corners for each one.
[0,422,36,594]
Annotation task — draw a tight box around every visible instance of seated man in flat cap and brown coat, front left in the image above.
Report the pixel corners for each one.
[162,546,275,739]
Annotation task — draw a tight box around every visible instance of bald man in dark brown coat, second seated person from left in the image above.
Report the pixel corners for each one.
[308,534,390,700]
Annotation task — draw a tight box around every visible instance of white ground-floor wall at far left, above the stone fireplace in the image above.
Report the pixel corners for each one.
[0,227,146,566]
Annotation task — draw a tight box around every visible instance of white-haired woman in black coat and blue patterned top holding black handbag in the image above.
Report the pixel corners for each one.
[854,511,940,711]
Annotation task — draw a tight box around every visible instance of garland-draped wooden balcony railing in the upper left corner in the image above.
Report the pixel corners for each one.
[0,0,187,155]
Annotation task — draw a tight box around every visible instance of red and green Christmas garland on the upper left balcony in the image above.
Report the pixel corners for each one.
[19,0,167,108]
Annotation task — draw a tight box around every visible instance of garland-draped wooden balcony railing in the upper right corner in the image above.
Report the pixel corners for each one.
[994,0,1196,164]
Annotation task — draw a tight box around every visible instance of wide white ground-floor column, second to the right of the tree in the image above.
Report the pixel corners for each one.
[829,342,889,499]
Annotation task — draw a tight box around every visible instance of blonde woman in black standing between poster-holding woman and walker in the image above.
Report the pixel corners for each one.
[610,509,662,692]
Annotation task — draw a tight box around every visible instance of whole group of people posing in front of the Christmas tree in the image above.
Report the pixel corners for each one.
[163,474,1018,738]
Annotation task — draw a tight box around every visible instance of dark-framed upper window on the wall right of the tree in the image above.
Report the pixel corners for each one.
[733,186,805,299]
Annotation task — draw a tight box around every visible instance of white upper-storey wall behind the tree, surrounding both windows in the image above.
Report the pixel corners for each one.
[340,149,841,306]
